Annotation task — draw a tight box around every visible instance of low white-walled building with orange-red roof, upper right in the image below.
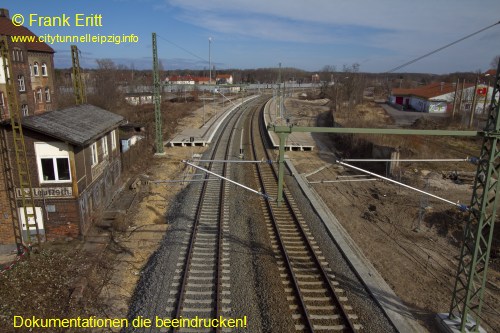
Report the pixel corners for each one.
[389,82,493,113]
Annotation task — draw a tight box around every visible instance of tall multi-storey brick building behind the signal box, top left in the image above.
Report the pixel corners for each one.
[0,8,56,120]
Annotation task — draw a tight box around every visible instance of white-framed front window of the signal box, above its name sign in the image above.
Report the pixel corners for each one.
[35,142,71,183]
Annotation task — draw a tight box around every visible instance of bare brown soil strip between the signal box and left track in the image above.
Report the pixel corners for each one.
[0,102,215,333]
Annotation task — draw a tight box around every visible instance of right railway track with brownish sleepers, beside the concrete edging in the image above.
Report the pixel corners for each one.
[250,103,362,332]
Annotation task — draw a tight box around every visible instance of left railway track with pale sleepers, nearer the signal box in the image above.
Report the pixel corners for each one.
[166,95,264,332]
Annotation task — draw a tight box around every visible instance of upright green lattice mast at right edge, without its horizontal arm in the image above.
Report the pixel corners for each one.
[449,61,500,332]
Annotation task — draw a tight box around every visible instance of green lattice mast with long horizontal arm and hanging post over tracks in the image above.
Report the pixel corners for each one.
[268,61,500,333]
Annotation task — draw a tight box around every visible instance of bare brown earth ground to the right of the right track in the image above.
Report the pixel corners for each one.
[287,95,500,332]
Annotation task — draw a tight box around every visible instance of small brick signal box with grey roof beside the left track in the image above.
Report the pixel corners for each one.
[0,105,124,244]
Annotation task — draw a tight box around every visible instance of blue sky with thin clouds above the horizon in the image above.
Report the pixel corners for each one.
[0,0,500,74]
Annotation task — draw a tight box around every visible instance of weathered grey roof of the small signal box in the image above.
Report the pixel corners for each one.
[22,104,125,146]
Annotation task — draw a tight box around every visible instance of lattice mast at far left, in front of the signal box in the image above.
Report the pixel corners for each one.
[0,36,41,252]
